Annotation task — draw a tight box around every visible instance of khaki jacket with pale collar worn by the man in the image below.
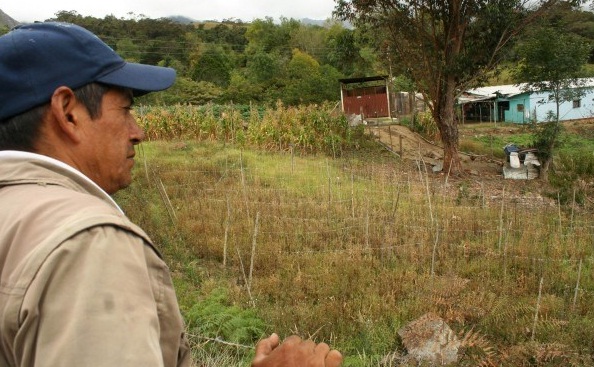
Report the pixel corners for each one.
[0,151,190,367]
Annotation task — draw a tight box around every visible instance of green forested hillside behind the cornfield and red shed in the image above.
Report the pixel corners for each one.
[0,3,594,105]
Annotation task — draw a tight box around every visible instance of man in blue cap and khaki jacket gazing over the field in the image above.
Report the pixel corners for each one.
[0,23,342,367]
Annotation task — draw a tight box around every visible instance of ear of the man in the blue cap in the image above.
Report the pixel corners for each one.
[50,87,86,143]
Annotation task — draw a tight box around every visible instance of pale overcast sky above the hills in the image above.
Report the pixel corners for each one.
[0,0,335,22]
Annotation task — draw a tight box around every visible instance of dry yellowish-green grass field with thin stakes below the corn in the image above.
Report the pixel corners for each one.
[117,141,594,366]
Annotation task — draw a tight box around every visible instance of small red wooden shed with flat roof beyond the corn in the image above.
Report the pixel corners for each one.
[339,76,391,118]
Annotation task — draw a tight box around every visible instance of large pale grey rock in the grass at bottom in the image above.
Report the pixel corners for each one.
[398,313,460,366]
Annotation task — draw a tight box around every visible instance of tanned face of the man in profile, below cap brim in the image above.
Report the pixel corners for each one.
[78,89,144,194]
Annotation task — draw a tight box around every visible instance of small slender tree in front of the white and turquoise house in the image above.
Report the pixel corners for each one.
[514,27,591,181]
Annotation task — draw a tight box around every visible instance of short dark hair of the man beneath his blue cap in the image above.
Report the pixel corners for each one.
[0,83,109,152]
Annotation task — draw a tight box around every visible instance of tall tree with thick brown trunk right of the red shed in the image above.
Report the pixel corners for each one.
[335,0,560,174]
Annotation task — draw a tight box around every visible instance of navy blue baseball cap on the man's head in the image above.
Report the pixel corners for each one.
[0,22,175,121]
